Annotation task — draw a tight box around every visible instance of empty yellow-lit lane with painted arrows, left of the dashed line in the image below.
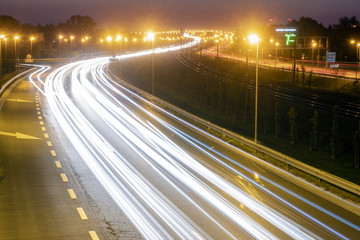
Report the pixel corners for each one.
[0,80,97,239]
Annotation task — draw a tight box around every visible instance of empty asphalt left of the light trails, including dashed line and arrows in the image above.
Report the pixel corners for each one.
[0,73,142,240]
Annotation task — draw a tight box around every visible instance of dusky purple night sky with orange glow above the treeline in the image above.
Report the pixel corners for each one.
[0,0,360,29]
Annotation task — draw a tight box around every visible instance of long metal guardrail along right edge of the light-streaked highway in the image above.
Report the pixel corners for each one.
[108,70,360,196]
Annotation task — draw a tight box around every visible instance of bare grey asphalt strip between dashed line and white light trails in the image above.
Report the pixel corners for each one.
[41,76,143,240]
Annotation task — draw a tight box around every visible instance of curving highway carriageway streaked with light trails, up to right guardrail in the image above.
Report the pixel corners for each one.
[34,39,360,239]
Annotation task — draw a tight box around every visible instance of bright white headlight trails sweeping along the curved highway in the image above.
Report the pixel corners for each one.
[43,38,356,239]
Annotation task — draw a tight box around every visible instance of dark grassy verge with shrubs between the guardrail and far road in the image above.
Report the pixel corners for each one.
[111,48,360,184]
